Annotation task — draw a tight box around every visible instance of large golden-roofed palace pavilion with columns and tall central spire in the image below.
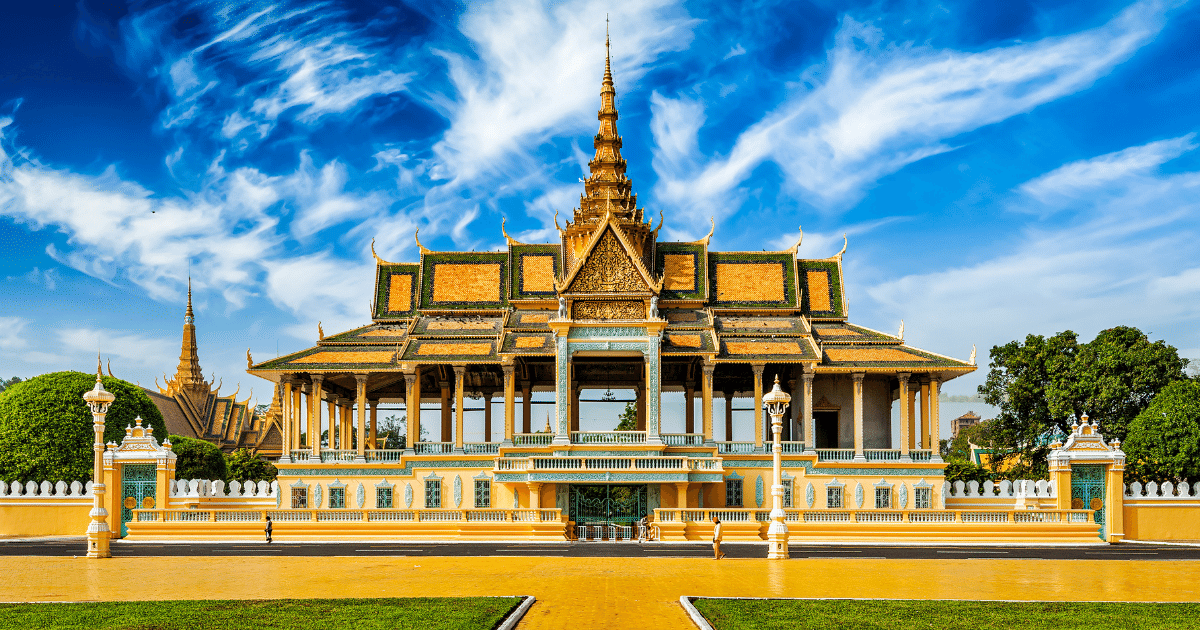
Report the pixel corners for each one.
[247,42,976,535]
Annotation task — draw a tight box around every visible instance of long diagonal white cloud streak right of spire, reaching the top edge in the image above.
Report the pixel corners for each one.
[655,0,1169,220]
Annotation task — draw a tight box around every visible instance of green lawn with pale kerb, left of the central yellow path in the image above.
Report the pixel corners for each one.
[0,598,521,630]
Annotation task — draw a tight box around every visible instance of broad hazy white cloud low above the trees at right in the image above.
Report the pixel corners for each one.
[865,134,1200,391]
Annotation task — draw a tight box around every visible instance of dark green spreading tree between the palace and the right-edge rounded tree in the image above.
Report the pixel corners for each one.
[979,326,1188,479]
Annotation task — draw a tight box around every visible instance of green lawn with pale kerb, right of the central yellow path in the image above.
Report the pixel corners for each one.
[694,597,1200,630]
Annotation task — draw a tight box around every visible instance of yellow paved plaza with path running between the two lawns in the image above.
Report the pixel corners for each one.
[0,557,1200,630]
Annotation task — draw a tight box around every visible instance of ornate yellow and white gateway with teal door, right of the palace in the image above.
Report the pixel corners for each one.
[1049,415,1124,542]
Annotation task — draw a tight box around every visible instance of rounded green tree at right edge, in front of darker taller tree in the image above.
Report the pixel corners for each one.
[1123,380,1200,481]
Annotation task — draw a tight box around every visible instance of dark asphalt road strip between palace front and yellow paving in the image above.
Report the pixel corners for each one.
[0,539,1200,560]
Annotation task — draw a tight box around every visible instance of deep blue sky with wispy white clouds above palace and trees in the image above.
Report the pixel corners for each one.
[0,0,1200,408]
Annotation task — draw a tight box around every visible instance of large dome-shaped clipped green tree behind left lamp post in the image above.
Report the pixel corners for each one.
[0,372,167,482]
